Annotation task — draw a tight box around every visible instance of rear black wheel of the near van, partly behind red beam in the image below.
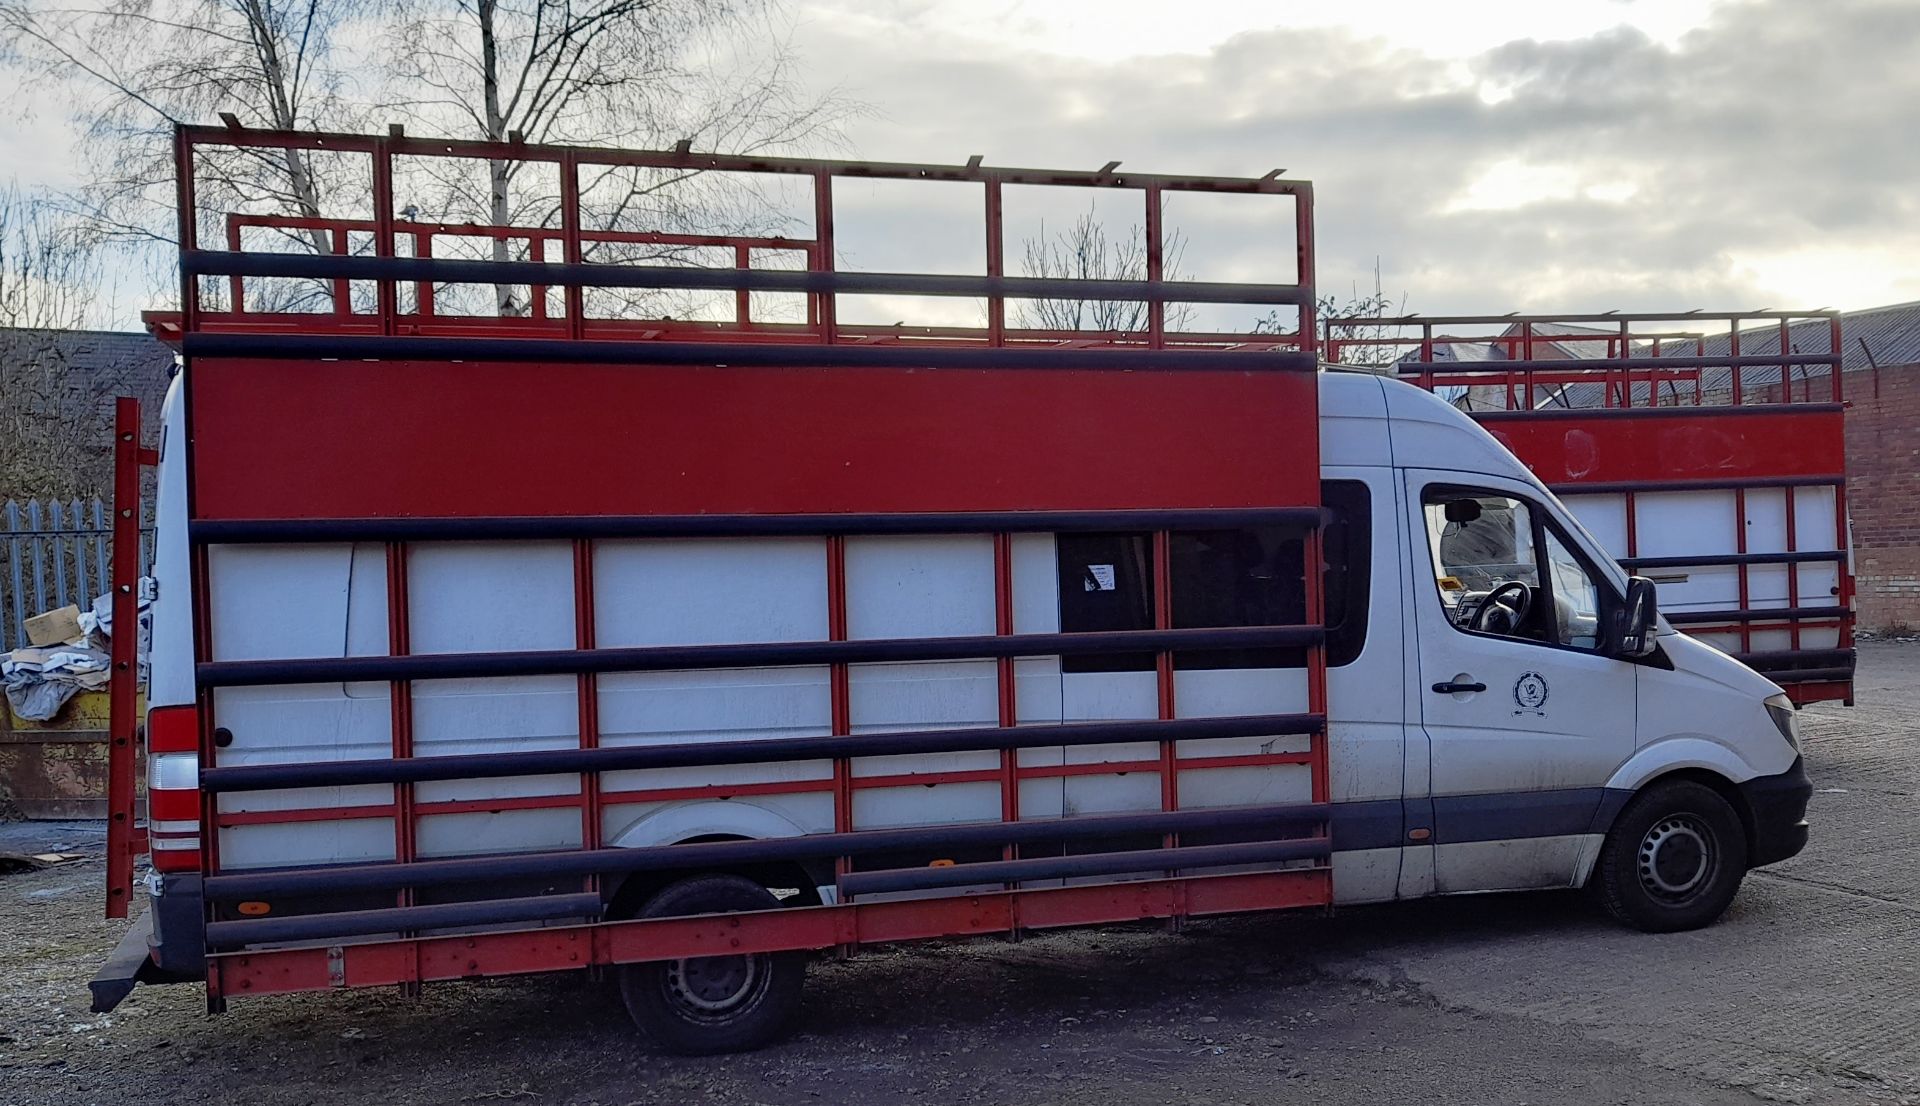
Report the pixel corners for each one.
[620,876,806,1056]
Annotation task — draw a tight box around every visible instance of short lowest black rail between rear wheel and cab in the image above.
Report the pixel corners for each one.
[839,837,1332,895]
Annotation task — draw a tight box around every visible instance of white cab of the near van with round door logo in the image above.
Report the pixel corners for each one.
[1321,373,1812,929]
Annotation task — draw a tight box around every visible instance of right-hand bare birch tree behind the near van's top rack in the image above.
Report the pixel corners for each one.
[384,0,860,315]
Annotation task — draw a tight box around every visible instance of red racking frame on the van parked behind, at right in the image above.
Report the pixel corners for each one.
[1323,311,1853,703]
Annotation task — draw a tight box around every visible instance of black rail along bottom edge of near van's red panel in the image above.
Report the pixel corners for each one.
[188,507,1327,545]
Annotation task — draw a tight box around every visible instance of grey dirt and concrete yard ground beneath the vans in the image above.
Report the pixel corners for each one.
[0,643,1920,1106]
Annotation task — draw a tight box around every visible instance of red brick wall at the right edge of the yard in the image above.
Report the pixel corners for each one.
[1845,365,1920,630]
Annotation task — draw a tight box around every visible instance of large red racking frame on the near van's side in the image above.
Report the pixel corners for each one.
[117,127,1331,1008]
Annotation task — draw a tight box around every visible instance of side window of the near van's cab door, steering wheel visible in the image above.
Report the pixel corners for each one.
[1421,486,1601,649]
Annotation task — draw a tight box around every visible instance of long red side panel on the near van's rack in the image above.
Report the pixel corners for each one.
[188,359,1319,518]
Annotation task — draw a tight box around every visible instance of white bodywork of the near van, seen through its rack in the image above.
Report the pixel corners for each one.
[152,373,1795,902]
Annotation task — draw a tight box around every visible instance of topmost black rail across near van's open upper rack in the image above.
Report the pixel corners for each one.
[180,250,1313,305]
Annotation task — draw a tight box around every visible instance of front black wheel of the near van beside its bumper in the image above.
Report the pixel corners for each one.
[1590,780,1747,933]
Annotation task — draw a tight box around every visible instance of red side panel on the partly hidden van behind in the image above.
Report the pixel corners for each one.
[1480,405,1845,484]
